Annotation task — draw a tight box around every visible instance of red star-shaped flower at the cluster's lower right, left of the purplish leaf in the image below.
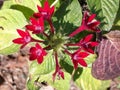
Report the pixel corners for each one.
[71,50,89,69]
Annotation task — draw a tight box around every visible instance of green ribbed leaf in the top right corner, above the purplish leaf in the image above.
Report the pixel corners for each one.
[87,0,120,31]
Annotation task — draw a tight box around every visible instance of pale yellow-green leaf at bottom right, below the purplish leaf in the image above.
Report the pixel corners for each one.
[76,68,110,90]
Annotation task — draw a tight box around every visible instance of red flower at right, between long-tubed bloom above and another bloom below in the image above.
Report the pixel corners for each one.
[76,34,99,54]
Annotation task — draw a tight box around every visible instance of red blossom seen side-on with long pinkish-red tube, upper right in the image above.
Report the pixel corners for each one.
[69,12,100,37]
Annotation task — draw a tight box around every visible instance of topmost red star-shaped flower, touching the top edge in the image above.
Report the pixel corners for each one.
[33,0,54,20]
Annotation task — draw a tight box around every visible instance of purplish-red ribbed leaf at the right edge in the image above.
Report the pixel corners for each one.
[92,31,120,80]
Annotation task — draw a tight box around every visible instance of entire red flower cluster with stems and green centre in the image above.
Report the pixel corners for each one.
[13,0,100,80]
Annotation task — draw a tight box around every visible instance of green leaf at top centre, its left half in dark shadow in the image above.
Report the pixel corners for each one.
[53,0,82,34]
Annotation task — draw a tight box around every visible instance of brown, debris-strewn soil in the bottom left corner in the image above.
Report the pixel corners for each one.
[0,48,28,90]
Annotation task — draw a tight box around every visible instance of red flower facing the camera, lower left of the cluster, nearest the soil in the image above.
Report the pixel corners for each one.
[30,43,47,64]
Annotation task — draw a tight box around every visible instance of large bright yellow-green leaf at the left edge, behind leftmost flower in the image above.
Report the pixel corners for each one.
[0,9,27,54]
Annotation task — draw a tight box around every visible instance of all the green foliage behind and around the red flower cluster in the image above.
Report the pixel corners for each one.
[0,0,120,90]
